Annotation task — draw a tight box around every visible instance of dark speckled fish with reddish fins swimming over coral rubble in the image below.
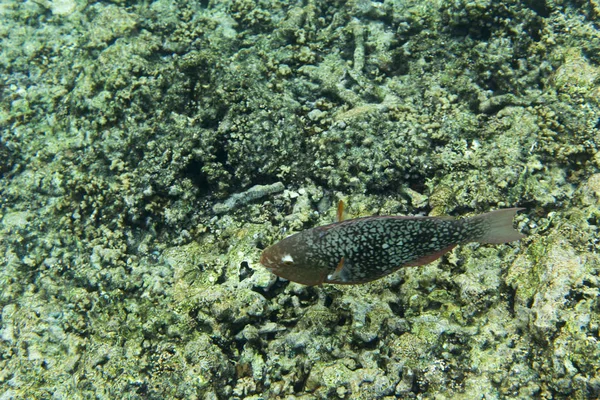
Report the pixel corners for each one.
[260,202,525,286]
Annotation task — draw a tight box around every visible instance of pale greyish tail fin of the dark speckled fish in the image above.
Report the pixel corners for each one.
[472,208,525,243]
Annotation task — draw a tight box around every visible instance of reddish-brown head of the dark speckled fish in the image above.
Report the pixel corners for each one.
[260,231,328,286]
